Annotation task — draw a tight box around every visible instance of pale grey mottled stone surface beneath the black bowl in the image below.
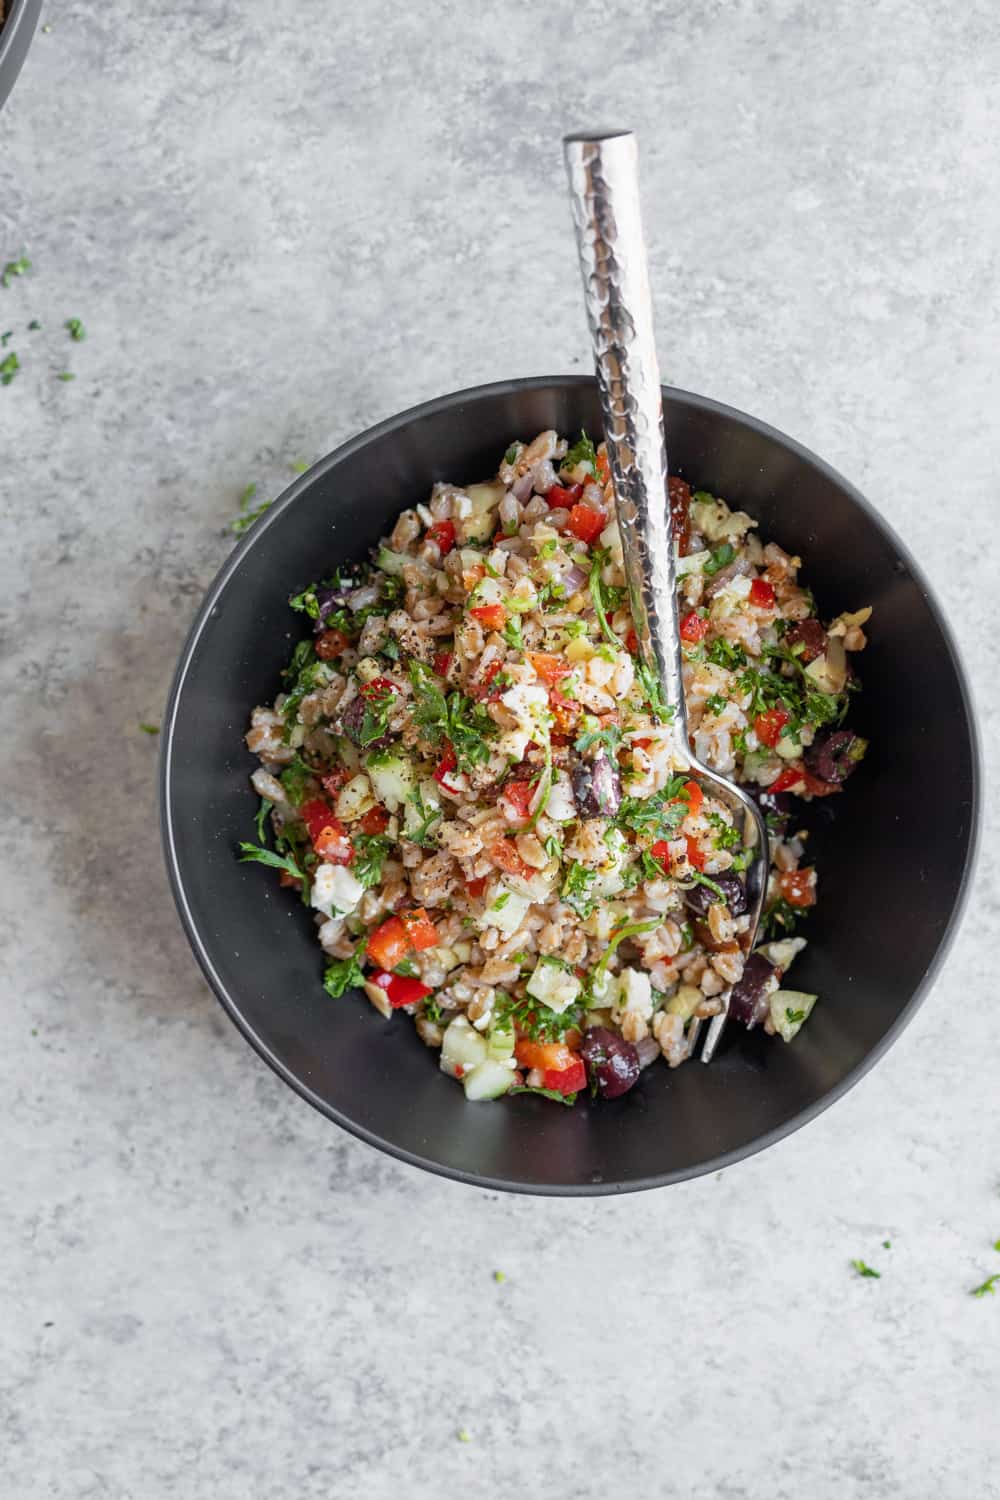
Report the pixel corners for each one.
[0,0,1000,1500]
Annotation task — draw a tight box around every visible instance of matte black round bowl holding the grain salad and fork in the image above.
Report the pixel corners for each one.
[162,377,978,1194]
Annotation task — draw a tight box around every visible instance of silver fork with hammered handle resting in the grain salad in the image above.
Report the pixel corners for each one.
[564,131,769,1062]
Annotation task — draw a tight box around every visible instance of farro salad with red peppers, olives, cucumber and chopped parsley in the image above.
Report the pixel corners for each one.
[240,432,871,1104]
